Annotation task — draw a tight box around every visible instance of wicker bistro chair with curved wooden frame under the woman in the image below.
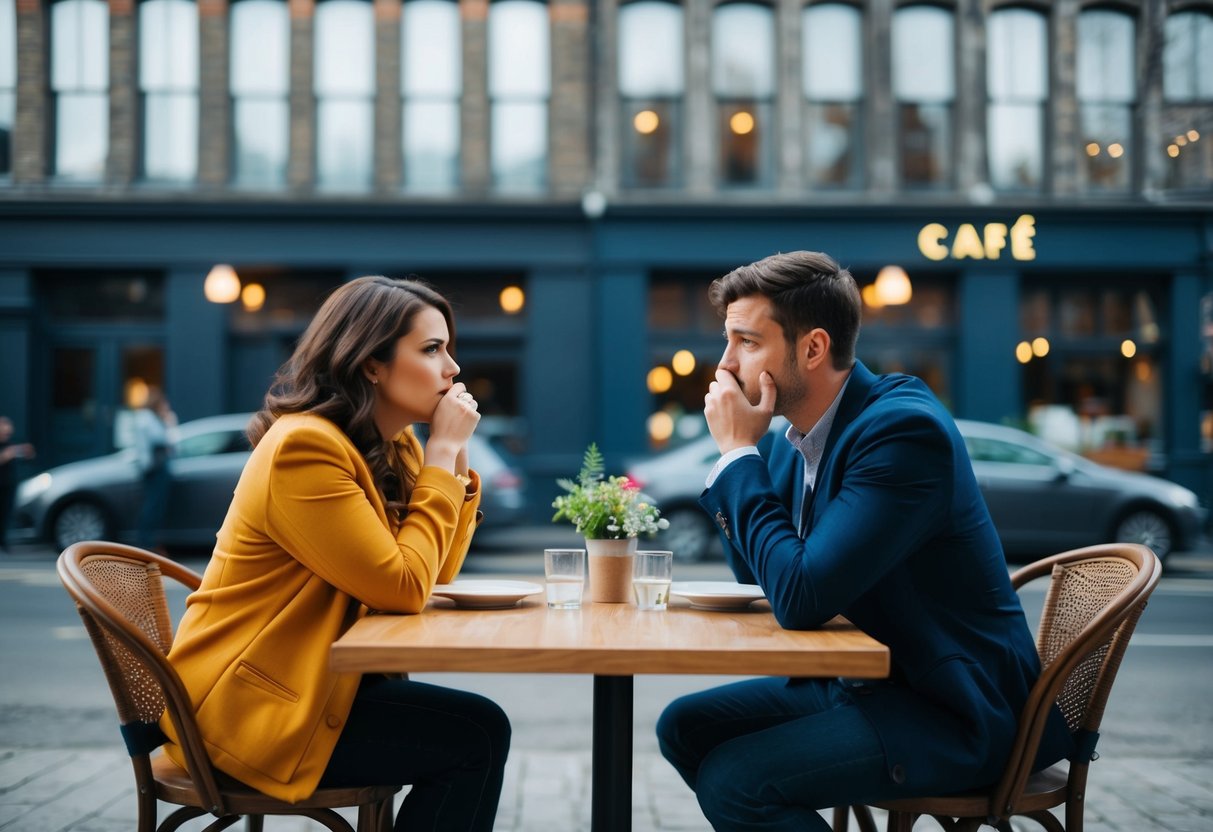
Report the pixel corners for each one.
[58,541,399,832]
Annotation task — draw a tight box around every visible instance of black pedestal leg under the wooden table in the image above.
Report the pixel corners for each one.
[590,676,632,832]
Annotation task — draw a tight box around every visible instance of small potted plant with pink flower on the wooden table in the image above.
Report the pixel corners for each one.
[552,444,670,604]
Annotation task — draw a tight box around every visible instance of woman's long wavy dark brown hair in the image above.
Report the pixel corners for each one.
[249,275,455,517]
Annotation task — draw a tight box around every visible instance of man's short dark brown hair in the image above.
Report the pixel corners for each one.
[707,251,861,370]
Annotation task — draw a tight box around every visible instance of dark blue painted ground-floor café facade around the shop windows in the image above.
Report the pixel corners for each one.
[0,200,1213,514]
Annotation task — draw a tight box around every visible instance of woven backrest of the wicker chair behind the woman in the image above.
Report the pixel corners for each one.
[58,541,231,811]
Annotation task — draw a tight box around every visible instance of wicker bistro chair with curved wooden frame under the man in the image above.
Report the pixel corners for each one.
[835,543,1162,832]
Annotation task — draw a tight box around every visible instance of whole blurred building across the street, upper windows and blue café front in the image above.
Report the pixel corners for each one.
[0,0,1213,517]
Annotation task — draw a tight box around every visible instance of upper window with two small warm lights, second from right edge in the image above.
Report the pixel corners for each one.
[1077,8,1137,192]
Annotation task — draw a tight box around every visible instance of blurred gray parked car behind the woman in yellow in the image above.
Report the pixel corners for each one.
[12,414,526,549]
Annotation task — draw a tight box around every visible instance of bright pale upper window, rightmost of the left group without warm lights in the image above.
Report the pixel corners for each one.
[489,0,552,193]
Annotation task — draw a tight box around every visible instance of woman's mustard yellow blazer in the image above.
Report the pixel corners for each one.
[160,414,480,800]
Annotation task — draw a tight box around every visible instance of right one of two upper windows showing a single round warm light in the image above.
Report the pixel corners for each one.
[712,2,775,186]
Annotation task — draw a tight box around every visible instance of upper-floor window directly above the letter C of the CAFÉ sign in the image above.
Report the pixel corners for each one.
[893,6,956,188]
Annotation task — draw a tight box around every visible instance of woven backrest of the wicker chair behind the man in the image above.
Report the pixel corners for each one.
[991,543,1162,817]
